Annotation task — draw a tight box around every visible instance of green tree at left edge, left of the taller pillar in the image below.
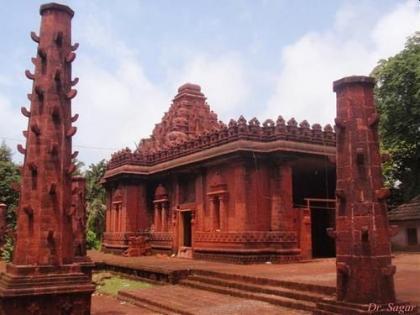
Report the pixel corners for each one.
[0,142,20,228]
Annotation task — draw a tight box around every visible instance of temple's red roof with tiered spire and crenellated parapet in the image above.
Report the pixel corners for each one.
[105,83,335,173]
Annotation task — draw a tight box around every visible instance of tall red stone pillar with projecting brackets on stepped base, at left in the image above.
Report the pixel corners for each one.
[0,3,94,315]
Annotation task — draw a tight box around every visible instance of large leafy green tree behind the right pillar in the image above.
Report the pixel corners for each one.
[372,32,420,202]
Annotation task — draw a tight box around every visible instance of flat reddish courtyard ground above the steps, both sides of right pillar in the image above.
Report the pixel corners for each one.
[88,251,420,305]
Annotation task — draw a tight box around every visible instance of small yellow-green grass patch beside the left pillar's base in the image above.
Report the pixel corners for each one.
[93,273,152,295]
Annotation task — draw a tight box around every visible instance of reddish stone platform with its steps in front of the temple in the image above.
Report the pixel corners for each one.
[89,251,420,314]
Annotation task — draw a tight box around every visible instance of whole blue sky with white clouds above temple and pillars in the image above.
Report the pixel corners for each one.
[0,0,420,164]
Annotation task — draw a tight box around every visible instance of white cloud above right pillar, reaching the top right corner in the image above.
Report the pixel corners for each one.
[265,1,420,124]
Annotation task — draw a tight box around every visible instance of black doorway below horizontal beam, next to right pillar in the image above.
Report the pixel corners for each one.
[311,208,335,258]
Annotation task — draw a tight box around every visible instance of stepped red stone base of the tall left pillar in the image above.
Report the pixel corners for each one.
[0,264,95,315]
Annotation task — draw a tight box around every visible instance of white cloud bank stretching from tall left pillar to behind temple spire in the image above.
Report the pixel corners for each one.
[73,5,248,163]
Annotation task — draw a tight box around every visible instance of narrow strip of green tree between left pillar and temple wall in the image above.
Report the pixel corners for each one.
[85,160,106,244]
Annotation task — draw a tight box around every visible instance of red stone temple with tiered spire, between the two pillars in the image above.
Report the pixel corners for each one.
[103,83,335,263]
